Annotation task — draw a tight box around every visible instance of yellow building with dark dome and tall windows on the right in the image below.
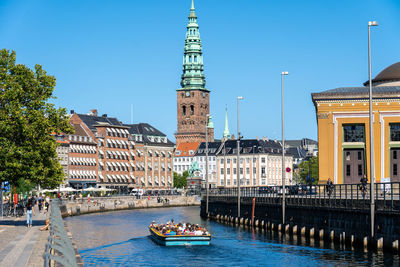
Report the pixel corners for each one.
[312,62,400,184]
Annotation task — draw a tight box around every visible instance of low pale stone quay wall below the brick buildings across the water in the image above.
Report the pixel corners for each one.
[60,196,200,217]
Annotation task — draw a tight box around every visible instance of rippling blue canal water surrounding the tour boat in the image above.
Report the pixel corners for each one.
[66,207,400,267]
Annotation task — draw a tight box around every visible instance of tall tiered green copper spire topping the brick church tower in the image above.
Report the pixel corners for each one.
[181,0,206,90]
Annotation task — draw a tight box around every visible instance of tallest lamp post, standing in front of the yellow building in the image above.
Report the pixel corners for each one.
[368,21,378,238]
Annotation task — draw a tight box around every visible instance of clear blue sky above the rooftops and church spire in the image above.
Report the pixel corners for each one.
[0,0,400,140]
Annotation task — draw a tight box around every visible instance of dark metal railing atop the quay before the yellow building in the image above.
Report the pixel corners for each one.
[202,183,400,212]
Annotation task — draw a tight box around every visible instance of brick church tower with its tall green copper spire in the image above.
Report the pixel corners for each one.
[175,0,214,145]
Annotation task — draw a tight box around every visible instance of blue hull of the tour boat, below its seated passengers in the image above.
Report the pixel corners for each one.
[149,227,211,246]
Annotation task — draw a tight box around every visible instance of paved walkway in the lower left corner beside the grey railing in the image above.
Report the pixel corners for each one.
[0,206,49,267]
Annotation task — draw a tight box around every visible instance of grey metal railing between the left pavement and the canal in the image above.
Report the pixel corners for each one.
[43,200,78,267]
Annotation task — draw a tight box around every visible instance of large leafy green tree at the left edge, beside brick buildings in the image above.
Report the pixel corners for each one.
[0,49,72,188]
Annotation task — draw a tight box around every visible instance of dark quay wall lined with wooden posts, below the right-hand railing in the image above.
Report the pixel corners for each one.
[200,197,400,253]
